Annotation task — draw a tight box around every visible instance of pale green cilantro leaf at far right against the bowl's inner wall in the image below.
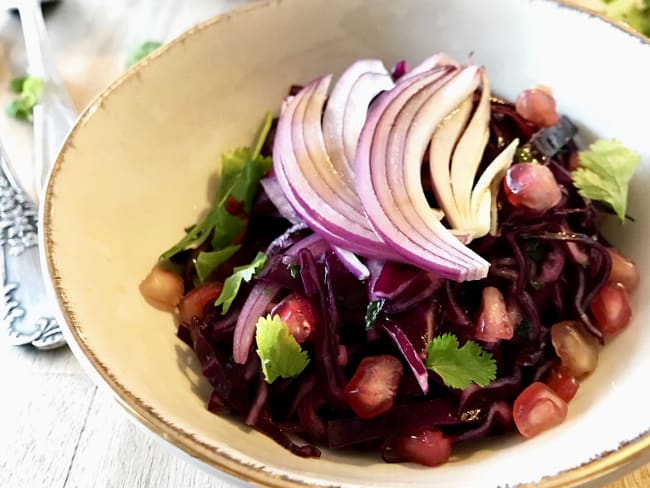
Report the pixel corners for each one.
[571,139,640,222]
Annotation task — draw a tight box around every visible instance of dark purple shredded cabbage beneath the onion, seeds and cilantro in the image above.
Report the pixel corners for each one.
[172,99,611,461]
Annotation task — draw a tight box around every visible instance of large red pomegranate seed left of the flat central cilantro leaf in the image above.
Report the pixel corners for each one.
[343,354,404,419]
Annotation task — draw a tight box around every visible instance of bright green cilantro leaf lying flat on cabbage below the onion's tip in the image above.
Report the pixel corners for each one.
[426,333,497,390]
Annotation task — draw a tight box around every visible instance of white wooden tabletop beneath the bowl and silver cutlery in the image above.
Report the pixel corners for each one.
[0,0,650,488]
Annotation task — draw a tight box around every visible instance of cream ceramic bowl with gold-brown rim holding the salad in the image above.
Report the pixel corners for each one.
[42,0,650,488]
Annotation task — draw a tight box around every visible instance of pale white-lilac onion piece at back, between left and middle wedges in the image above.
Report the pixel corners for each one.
[323,59,394,184]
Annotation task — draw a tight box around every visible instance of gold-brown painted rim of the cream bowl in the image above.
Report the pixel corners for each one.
[39,0,650,488]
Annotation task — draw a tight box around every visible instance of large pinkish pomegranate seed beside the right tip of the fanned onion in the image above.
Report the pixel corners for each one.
[503,163,562,213]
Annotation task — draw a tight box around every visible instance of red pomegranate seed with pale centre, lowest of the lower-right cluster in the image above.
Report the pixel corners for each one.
[512,381,568,438]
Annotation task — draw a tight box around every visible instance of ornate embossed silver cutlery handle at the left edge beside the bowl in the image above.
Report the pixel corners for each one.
[0,142,65,349]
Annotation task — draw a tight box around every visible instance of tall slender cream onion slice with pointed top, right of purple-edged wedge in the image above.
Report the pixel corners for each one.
[451,73,490,226]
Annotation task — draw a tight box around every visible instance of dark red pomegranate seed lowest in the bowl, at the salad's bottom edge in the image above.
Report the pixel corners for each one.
[395,428,451,466]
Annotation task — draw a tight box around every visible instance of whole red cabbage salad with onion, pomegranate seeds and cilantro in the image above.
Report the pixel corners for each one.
[140,53,639,466]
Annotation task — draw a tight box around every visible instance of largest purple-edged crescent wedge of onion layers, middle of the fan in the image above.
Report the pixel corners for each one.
[355,63,489,280]
